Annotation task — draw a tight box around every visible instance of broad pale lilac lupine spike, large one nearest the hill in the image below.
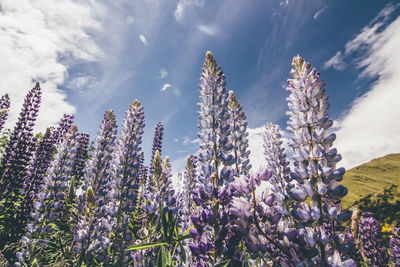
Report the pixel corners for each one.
[286,56,351,264]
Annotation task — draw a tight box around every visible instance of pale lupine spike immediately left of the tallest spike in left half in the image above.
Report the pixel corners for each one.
[74,110,117,262]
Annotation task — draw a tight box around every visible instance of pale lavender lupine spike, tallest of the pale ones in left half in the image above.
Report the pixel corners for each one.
[110,99,144,263]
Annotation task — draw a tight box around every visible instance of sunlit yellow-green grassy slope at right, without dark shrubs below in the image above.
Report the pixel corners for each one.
[342,154,400,208]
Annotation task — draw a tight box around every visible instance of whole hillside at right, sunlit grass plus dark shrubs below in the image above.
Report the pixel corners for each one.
[342,154,400,223]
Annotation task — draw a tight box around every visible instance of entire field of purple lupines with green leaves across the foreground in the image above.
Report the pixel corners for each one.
[0,52,400,266]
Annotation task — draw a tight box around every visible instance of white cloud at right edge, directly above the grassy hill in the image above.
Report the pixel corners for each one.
[335,6,400,168]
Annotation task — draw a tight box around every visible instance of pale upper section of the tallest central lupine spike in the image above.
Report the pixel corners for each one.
[198,51,235,187]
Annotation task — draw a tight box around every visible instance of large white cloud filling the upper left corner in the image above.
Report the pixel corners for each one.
[0,0,102,131]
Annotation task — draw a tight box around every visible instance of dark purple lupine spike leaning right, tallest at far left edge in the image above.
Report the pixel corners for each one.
[0,83,42,245]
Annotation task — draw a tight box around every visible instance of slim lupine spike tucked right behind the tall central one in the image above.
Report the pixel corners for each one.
[228,91,251,175]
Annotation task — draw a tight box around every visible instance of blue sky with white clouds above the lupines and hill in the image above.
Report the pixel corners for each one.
[0,0,400,175]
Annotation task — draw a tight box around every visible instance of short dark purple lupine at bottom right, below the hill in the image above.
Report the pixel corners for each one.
[358,215,389,266]
